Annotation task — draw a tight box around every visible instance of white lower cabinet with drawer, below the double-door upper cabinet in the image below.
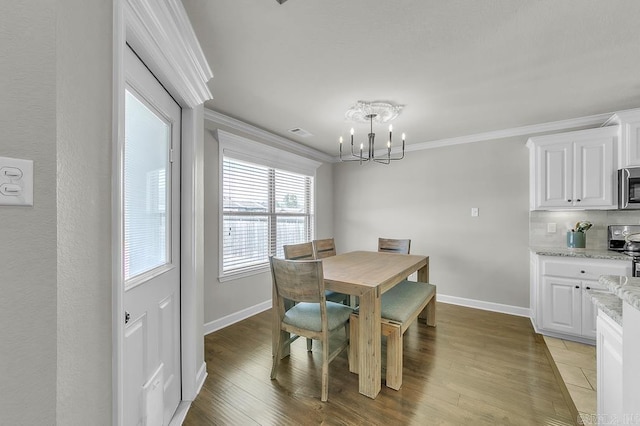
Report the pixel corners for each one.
[532,256,631,342]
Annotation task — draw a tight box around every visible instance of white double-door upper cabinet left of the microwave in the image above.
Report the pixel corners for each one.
[527,127,616,210]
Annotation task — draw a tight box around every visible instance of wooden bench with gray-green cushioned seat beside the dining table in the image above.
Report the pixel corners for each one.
[349,280,436,390]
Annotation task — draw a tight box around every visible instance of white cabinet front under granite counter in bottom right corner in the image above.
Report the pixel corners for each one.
[596,310,624,424]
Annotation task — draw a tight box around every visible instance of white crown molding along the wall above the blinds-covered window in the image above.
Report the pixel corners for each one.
[204,108,336,163]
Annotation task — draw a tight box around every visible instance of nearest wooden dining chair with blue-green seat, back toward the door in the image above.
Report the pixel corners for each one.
[269,257,353,402]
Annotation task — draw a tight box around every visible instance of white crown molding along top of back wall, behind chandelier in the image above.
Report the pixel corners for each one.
[333,112,614,162]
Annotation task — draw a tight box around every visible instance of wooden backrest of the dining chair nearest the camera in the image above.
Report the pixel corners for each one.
[269,256,325,305]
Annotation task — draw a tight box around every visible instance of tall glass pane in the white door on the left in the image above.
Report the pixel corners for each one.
[124,90,171,280]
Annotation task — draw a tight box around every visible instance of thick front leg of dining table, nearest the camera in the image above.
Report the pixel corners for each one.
[358,289,382,398]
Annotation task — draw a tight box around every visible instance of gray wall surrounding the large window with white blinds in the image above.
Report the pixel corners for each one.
[204,122,333,324]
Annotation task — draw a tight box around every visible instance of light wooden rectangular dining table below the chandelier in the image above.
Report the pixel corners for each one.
[274,251,429,398]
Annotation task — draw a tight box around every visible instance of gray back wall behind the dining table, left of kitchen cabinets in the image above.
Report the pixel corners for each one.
[333,137,529,308]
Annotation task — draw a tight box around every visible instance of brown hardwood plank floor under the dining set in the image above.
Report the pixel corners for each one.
[184,303,575,426]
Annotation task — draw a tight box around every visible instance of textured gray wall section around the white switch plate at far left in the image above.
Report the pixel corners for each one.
[0,0,57,425]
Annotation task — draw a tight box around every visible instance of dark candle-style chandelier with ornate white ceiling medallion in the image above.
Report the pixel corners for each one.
[340,101,404,164]
